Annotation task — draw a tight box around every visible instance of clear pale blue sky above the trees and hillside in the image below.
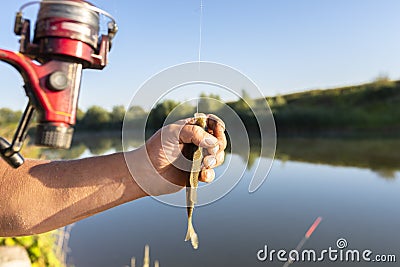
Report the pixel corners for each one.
[0,0,400,109]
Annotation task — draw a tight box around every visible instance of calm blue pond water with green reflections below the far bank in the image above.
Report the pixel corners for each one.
[51,138,400,267]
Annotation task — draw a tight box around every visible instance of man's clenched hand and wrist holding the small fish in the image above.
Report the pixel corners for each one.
[126,115,226,195]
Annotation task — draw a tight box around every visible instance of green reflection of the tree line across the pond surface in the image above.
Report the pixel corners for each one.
[43,132,400,179]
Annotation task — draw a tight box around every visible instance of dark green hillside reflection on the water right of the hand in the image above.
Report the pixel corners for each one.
[276,138,400,179]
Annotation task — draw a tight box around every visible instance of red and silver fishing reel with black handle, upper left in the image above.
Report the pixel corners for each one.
[0,0,118,168]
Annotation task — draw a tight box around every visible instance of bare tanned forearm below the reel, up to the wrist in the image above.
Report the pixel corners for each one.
[0,153,145,236]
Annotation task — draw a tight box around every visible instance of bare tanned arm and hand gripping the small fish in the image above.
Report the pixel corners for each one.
[0,115,226,237]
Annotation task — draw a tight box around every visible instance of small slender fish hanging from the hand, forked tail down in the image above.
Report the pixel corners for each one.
[185,113,207,249]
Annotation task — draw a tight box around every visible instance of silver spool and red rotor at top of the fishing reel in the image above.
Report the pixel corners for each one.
[14,0,118,69]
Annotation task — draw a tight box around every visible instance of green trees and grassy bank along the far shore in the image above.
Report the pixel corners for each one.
[0,77,400,135]
